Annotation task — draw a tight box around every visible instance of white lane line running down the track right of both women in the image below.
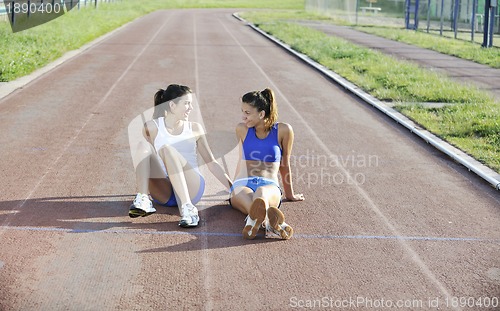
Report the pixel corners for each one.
[219,20,461,310]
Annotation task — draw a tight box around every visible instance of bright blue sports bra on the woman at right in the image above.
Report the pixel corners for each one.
[243,123,282,162]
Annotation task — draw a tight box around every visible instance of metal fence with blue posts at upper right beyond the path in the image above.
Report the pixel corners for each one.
[306,0,500,46]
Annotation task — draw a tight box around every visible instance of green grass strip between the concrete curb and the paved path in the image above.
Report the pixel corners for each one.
[242,12,500,172]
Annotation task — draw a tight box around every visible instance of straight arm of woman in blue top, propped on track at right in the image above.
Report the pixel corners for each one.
[278,123,304,201]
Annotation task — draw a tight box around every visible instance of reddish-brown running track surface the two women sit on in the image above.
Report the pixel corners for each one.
[0,10,500,311]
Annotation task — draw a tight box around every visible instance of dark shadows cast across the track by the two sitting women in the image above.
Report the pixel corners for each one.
[0,194,280,253]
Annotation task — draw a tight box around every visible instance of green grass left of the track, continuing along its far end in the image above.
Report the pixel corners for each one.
[0,0,304,82]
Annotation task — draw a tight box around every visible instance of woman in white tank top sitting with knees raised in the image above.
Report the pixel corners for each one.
[129,84,231,227]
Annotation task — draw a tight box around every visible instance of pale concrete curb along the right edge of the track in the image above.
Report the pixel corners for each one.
[233,13,500,190]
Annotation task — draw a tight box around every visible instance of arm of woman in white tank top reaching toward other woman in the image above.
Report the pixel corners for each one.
[192,122,233,190]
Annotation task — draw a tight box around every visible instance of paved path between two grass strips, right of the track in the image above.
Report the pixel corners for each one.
[301,21,500,102]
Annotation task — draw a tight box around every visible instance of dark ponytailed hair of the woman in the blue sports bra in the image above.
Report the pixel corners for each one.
[241,88,278,131]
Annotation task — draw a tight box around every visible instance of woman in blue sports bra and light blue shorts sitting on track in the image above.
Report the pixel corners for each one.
[230,88,304,239]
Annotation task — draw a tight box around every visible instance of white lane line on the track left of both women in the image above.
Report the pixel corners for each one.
[3,16,174,233]
